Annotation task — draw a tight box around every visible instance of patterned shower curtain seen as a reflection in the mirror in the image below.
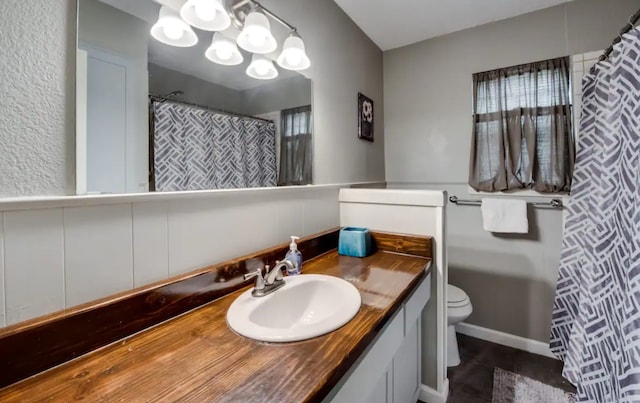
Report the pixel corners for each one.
[153,102,277,191]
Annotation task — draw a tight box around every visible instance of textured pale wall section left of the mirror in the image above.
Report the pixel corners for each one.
[0,0,75,197]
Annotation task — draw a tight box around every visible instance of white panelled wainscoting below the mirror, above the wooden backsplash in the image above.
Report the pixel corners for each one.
[0,185,344,326]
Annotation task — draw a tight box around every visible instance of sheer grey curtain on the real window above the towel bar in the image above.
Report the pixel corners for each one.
[469,57,574,193]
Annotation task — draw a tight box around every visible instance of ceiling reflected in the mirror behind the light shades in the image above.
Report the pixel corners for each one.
[97,0,304,91]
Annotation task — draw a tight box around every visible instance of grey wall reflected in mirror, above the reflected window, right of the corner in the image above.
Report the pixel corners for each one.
[242,75,311,115]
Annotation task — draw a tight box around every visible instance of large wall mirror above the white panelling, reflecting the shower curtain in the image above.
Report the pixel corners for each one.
[76,0,313,194]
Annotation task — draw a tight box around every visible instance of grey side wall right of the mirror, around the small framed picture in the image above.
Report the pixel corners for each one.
[262,0,385,183]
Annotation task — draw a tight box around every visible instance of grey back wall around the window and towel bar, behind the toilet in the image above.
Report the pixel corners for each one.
[384,0,638,342]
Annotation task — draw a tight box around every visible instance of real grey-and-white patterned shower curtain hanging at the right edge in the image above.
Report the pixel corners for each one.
[550,29,640,402]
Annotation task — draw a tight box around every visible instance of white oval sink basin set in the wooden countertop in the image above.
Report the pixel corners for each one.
[227,274,361,342]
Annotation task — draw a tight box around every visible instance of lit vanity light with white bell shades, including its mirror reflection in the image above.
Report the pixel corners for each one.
[151,0,311,80]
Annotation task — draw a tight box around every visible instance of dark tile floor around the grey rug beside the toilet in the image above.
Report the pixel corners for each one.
[447,334,575,403]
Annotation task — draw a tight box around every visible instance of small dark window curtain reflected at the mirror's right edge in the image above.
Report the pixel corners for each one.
[278,105,313,186]
